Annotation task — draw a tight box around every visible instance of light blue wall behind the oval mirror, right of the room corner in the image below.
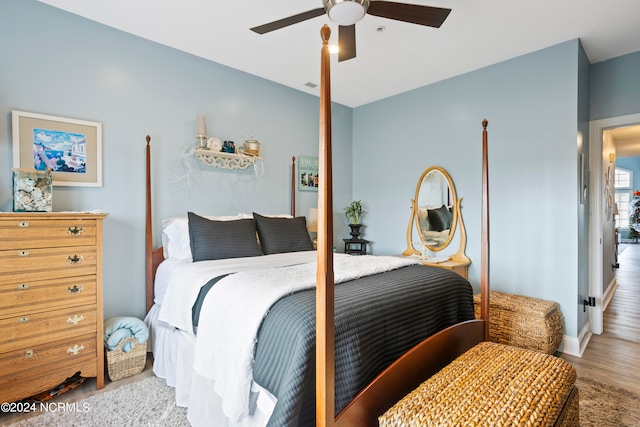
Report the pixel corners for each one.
[353,40,588,337]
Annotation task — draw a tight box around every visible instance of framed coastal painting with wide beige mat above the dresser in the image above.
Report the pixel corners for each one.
[12,110,102,187]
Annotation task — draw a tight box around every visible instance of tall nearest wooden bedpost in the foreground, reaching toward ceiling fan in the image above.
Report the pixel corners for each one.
[316,24,335,427]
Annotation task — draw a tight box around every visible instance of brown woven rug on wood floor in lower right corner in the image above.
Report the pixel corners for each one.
[576,378,640,427]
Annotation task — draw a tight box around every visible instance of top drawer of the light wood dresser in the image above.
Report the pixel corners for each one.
[0,216,97,250]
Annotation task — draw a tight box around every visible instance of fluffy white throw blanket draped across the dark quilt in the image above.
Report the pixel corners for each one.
[189,254,418,421]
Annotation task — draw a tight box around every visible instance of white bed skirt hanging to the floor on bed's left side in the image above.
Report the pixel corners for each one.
[144,304,276,427]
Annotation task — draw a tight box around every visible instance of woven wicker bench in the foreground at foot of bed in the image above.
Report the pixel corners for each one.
[378,342,579,427]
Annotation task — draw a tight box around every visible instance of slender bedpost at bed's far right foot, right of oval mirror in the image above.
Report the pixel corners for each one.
[480,119,489,341]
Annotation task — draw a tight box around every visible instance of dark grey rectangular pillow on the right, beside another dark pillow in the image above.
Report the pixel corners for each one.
[253,212,313,255]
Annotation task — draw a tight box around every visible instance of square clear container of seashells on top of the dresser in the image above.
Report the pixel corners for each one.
[13,168,53,212]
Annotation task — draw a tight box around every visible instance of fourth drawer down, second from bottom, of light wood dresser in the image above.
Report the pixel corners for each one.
[0,305,96,354]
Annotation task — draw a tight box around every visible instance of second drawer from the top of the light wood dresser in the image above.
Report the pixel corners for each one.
[0,246,97,284]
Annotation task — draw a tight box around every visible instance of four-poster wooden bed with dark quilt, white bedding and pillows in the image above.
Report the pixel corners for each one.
[146,26,576,427]
